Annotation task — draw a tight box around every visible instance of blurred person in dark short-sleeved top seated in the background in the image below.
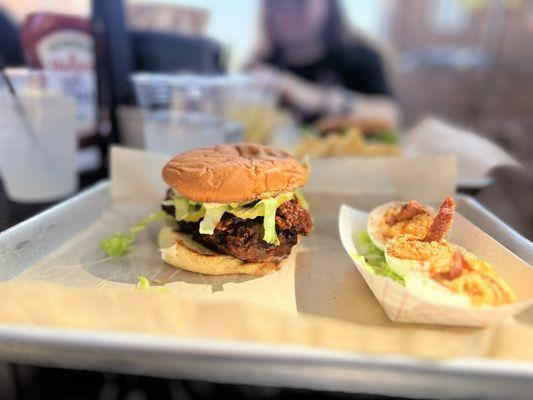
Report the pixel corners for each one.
[253,0,398,131]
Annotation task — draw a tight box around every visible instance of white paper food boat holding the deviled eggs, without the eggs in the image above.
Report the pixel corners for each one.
[339,205,533,327]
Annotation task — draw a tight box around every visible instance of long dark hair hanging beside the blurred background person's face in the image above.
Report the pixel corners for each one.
[259,0,352,64]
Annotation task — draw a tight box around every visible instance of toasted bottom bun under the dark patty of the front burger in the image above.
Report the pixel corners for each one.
[158,225,286,276]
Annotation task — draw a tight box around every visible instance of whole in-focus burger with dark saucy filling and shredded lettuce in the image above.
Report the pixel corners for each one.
[159,144,312,275]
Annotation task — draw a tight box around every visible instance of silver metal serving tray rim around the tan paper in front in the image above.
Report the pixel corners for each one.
[0,182,533,399]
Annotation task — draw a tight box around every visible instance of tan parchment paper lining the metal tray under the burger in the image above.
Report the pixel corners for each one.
[0,148,533,361]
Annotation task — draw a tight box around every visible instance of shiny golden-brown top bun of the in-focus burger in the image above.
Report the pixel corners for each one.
[163,143,308,203]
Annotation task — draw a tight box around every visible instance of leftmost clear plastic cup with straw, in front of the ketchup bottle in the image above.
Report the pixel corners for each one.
[0,70,77,202]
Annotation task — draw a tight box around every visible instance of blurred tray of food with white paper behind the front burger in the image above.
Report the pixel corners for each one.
[272,117,522,189]
